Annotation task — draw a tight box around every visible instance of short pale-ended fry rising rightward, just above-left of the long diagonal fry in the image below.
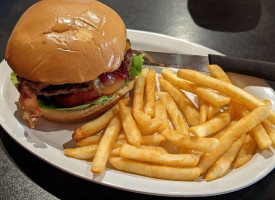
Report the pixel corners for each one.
[192,110,233,137]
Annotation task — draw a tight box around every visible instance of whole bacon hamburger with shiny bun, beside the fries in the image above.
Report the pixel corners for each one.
[5,0,142,128]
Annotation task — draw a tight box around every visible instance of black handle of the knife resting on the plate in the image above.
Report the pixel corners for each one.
[208,54,275,81]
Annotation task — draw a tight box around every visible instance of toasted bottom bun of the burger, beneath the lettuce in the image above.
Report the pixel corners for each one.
[41,79,135,123]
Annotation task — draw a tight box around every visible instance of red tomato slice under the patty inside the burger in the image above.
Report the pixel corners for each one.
[55,90,101,108]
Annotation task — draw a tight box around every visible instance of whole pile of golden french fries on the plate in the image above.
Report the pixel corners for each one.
[64,65,275,181]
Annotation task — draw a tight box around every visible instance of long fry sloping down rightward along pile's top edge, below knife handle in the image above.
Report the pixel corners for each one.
[177,69,275,125]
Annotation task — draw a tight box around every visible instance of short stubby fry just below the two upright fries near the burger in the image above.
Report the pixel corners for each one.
[133,110,162,135]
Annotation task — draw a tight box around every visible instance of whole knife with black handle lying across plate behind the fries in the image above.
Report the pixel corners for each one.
[133,50,275,81]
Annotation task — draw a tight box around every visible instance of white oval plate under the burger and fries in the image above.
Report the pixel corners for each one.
[0,30,275,196]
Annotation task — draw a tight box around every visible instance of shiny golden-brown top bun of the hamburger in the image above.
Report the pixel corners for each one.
[5,0,126,85]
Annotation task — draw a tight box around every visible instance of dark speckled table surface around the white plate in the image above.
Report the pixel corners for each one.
[0,0,275,199]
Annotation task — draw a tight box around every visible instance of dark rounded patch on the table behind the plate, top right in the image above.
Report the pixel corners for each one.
[187,0,261,32]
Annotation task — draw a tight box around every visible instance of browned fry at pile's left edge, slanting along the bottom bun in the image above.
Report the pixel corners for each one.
[72,97,130,142]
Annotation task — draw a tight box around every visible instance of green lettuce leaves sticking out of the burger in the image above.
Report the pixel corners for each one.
[11,55,143,110]
